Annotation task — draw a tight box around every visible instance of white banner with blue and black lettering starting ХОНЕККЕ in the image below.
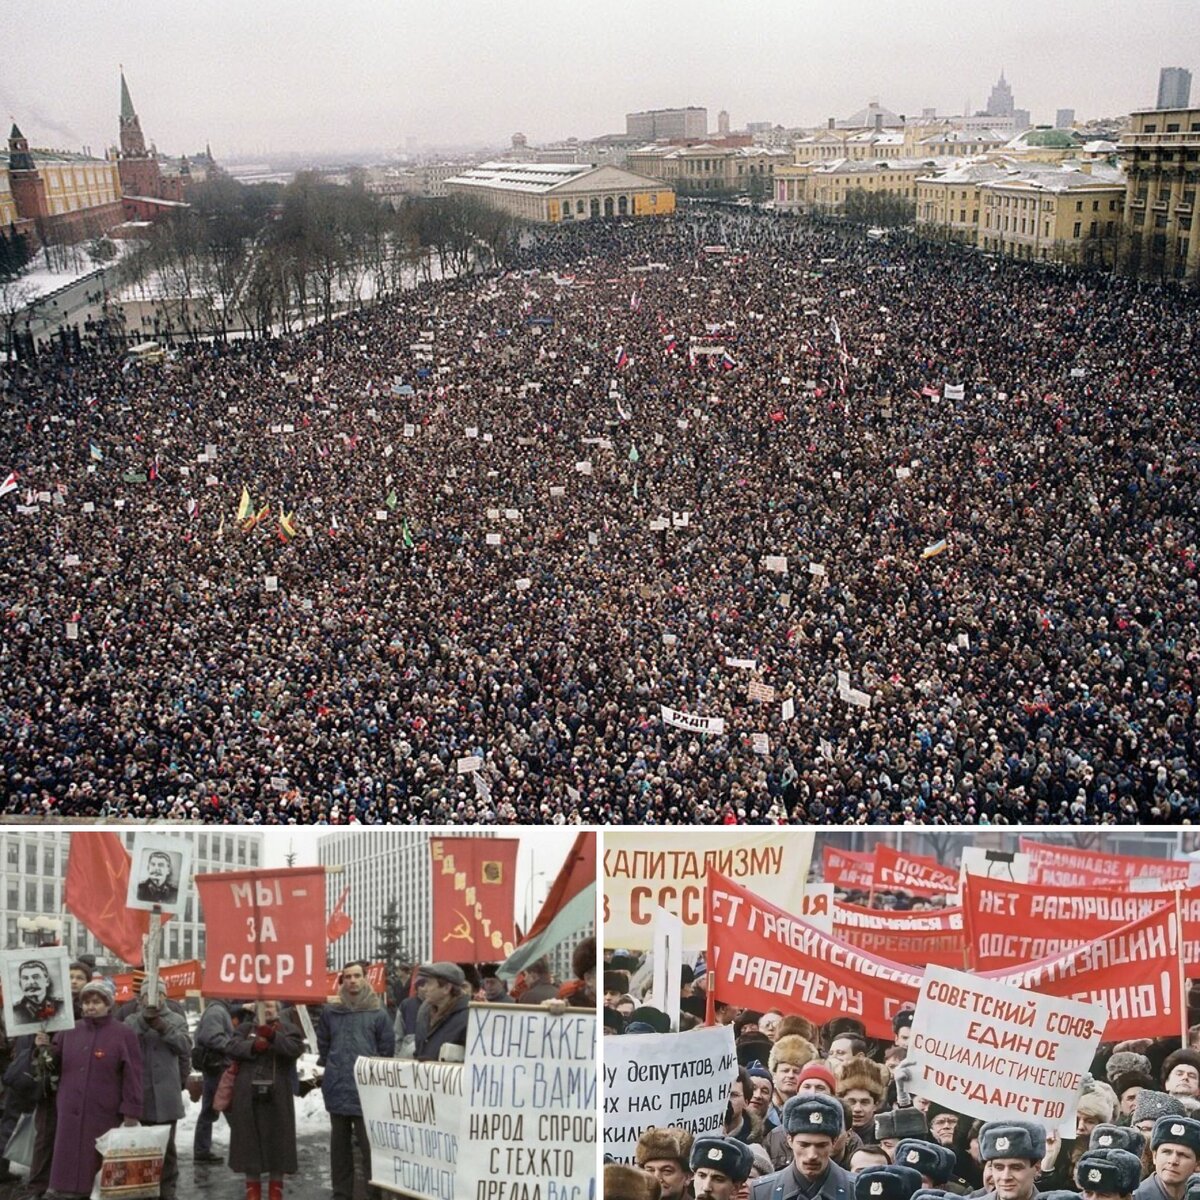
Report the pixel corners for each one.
[457,1004,598,1200]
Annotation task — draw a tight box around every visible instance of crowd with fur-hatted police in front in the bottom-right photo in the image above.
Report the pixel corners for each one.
[602,950,1200,1200]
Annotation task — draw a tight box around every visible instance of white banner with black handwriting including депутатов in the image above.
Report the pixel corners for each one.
[604,1025,738,1163]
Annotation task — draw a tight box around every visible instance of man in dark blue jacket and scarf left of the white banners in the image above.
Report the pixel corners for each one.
[317,960,396,1200]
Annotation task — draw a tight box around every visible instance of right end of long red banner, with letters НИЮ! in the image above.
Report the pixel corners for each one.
[986,898,1187,1042]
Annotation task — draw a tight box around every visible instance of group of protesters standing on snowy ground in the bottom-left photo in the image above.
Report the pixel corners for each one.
[0,938,596,1200]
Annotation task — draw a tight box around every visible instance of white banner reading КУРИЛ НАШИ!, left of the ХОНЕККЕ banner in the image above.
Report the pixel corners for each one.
[354,1057,464,1200]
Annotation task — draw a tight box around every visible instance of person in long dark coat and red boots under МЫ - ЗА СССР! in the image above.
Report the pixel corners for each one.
[229,1000,304,1200]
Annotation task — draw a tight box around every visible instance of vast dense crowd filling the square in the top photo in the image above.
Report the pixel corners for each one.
[0,208,1200,823]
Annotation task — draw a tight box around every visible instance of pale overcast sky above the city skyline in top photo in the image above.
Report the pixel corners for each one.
[0,0,1200,158]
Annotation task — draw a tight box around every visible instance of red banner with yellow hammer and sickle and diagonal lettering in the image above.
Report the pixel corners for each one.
[430,838,518,962]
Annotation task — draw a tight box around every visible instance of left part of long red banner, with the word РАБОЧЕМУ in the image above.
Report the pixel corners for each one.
[706,871,920,1038]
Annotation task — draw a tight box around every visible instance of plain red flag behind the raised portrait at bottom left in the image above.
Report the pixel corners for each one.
[64,832,150,967]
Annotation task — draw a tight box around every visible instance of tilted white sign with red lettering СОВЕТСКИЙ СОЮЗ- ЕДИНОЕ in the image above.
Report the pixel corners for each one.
[908,965,1109,1136]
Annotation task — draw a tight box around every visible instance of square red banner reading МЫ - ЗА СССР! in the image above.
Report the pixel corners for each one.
[196,866,329,1003]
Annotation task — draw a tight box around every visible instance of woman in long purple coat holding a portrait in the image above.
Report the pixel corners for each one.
[34,979,143,1200]
